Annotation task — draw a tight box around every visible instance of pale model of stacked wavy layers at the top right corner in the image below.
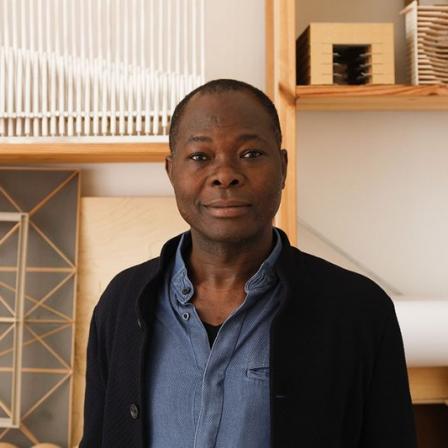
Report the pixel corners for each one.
[402,0,448,84]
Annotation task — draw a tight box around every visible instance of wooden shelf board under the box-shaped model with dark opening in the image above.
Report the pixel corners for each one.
[296,84,448,111]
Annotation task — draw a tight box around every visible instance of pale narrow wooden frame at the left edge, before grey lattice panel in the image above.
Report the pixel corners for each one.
[0,212,28,428]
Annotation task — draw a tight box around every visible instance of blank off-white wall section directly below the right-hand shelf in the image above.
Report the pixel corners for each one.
[297,112,448,296]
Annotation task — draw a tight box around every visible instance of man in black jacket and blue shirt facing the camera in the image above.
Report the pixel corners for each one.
[81,80,416,448]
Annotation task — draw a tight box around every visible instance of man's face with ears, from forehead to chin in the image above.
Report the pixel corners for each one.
[165,91,287,243]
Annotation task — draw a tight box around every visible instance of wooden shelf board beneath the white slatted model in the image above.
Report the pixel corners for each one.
[0,142,169,164]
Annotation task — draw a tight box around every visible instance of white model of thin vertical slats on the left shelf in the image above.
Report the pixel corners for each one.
[0,0,205,142]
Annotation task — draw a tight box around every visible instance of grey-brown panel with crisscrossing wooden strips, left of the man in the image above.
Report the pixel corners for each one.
[0,168,80,447]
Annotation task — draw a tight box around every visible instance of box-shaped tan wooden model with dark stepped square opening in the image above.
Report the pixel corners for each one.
[297,23,395,85]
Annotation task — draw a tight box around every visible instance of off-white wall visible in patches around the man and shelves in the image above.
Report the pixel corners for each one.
[40,0,448,296]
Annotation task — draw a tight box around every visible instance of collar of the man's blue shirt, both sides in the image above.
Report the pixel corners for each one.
[170,227,282,304]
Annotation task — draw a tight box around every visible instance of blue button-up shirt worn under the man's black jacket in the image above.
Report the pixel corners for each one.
[147,228,282,448]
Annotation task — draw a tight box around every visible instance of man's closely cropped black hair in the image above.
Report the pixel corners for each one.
[169,79,282,154]
